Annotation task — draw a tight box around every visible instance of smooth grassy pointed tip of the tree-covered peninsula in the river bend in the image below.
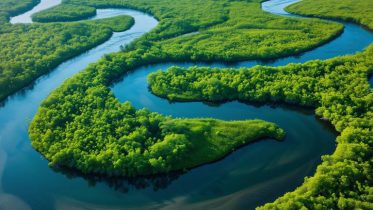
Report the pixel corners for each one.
[164,119,285,169]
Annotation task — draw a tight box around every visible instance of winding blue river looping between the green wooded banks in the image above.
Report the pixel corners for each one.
[0,0,373,210]
